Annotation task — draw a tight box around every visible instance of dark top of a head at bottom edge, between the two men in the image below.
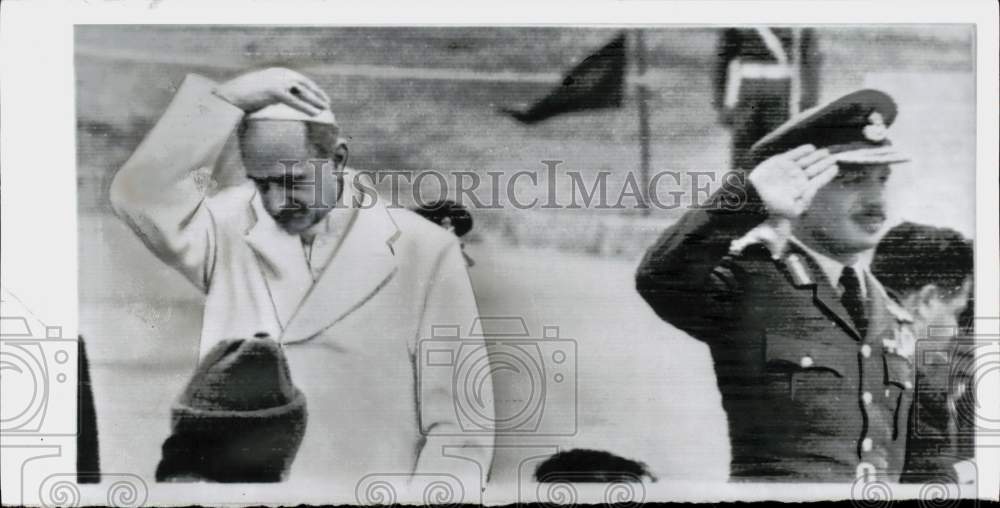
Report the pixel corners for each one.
[535,448,656,483]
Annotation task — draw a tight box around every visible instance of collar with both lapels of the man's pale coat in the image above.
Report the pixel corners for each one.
[244,171,400,343]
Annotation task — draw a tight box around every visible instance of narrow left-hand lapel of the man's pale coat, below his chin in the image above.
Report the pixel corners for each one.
[245,193,313,329]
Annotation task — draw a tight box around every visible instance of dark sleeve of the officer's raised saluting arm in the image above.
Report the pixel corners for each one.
[635,172,767,342]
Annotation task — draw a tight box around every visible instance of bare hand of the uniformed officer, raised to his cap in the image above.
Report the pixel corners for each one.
[747,145,839,219]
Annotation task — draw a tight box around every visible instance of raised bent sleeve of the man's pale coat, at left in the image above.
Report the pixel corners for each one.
[110,75,243,292]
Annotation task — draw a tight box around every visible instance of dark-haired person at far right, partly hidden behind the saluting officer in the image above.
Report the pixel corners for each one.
[872,222,975,482]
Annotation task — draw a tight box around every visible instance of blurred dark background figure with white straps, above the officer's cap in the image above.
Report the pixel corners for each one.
[713,26,820,170]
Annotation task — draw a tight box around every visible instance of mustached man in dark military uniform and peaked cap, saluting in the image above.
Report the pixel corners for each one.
[636,90,912,481]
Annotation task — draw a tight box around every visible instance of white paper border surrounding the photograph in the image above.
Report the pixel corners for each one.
[0,0,1000,505]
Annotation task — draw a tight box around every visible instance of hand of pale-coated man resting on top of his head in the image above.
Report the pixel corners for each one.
[215,67,330,115]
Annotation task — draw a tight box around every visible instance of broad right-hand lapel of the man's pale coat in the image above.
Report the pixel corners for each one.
[282,198,400,343]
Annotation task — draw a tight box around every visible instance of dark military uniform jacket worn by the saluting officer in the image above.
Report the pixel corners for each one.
[636,186,913,482]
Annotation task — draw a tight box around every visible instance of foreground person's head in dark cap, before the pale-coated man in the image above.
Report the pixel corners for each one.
[156,338,307,483]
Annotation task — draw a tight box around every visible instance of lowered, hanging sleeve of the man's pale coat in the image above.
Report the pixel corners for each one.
[415,238,495,488]
